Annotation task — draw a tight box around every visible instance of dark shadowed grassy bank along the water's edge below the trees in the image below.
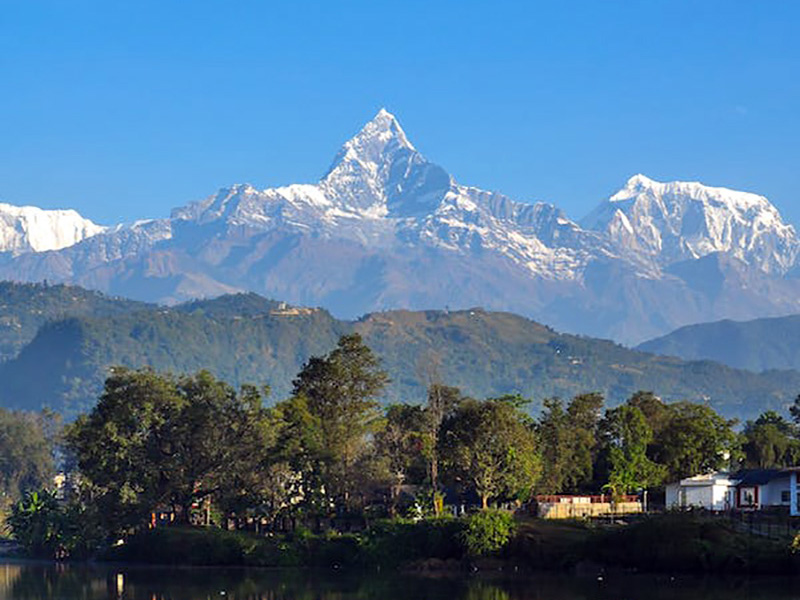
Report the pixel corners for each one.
[97,515,800,574]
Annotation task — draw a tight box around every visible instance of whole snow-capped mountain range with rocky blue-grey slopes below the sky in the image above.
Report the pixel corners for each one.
[0,110,800,343]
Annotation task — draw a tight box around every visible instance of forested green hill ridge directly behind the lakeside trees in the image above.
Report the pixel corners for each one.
[0,294,800,418]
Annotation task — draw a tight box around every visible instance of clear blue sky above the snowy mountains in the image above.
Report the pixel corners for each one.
[0,0,800,226]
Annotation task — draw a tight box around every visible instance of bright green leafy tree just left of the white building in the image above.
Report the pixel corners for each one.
[599,404,666,495]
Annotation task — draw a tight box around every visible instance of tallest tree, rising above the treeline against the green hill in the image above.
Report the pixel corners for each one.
[293,334,389,506]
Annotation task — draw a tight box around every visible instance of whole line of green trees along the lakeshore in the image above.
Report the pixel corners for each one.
[6,334,800,554]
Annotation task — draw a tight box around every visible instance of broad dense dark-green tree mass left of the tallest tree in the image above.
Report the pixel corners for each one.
[67,368,268,534]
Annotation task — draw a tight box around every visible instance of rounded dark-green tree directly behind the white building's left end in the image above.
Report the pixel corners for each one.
[658,402,737,481]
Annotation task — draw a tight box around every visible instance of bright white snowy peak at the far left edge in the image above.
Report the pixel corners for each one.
[0,203,105,254]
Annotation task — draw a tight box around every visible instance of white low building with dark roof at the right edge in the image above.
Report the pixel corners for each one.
[666,467,800,516]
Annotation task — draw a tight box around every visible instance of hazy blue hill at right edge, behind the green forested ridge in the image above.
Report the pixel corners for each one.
[638,315,800,376]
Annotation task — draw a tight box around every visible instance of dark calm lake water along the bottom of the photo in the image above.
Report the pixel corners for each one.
[0,563,800,600]
